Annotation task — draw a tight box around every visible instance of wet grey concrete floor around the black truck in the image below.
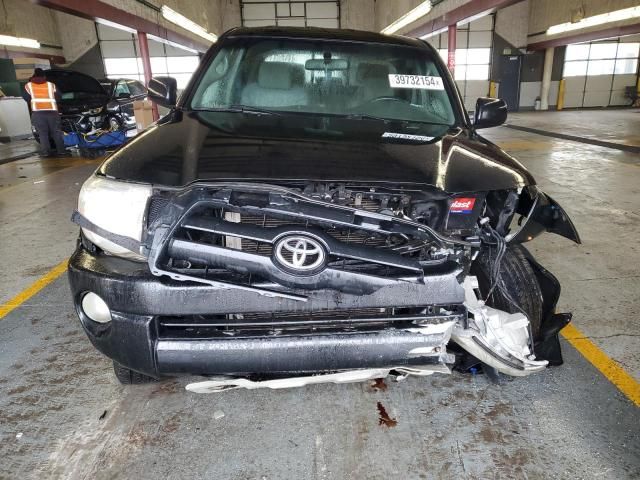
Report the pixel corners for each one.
[0,110,640,479]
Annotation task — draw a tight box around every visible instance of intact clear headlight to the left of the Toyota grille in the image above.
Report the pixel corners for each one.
[78,174,151,261]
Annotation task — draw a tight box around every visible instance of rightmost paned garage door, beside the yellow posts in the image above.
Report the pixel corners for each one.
[563,35,640,108]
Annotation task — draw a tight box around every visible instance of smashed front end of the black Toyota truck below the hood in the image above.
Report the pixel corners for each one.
[71,172,579,391]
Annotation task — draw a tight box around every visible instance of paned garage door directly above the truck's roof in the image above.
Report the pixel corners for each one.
[240,0,340,28]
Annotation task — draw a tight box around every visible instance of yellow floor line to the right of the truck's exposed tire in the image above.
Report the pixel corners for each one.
[562,324,640,407]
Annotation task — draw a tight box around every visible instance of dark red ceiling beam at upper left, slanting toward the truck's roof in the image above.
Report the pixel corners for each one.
[32,0,209,52]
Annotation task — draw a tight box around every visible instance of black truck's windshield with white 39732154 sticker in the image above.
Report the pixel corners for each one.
[190,38,455,126]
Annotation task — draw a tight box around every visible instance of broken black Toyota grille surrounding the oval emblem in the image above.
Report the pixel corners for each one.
[147,188,448,300]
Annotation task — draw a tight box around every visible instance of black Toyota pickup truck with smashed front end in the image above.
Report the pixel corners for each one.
[69,27,580,391]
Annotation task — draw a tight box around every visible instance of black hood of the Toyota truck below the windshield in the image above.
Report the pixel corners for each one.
[99,112,535,192]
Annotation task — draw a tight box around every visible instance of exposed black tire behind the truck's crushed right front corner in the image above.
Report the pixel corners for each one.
[471,245,543,339]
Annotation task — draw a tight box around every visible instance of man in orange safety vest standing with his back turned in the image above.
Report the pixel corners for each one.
[24,68,71,157]
